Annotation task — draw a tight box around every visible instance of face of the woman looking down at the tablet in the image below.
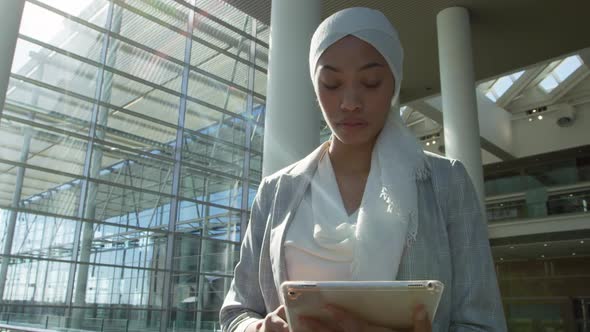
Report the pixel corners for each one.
[314,36,395,145]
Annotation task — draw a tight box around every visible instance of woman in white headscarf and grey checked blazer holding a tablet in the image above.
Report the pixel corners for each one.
[220,8,506,331]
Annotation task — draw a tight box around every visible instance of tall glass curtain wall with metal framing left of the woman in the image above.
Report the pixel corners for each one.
[0,0,269,331]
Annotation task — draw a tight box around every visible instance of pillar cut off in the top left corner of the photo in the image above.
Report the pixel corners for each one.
[0,0,25,118]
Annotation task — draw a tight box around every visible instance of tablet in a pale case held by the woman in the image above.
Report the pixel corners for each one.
[281,280,444,332]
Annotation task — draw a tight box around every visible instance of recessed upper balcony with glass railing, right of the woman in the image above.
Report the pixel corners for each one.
[484,154,590,222]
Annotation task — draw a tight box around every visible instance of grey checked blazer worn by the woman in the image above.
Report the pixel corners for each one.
[220,145,506,331]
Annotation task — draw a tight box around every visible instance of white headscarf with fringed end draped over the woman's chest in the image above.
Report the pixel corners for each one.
[309,7,430,280]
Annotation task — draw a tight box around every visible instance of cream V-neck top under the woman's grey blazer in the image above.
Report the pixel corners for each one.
[284,153,358,281]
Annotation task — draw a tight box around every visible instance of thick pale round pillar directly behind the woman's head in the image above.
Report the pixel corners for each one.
[262,0,321,176]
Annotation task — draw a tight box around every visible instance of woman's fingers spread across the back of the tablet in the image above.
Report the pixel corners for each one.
[300,306,432,332]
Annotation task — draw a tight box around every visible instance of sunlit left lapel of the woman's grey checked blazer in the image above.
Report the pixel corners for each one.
[269,142,329,292]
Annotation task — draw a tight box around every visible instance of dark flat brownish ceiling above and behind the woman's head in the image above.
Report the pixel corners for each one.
[225,0,590,103]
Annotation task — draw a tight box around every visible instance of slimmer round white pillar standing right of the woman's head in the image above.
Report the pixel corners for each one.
[436,7,485,206]
